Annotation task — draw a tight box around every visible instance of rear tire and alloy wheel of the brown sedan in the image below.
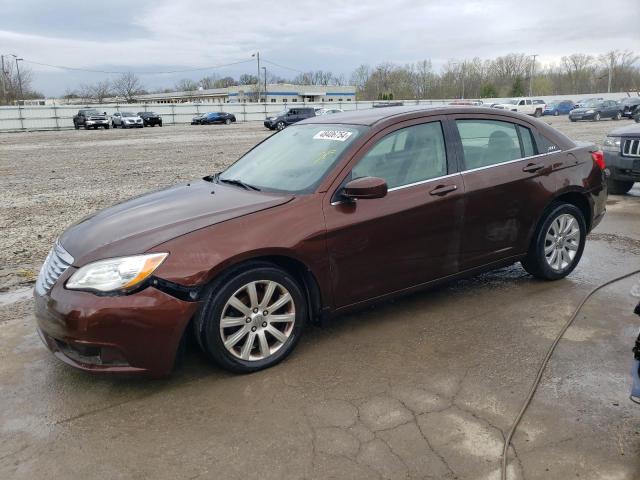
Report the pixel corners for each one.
[521,203,587,280]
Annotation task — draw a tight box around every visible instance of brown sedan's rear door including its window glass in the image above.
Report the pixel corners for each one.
[454,115,555,270]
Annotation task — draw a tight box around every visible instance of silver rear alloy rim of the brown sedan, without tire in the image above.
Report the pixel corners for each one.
[544,213,580,272]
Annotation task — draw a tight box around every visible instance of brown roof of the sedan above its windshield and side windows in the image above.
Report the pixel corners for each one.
[298,105,536,126]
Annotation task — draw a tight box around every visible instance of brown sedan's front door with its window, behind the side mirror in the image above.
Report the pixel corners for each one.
[324,117,464,308]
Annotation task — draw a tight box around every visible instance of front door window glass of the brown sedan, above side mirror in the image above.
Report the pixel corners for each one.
[351,122,447,188]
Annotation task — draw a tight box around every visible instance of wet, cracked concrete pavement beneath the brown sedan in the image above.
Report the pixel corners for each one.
[0,117,640,480]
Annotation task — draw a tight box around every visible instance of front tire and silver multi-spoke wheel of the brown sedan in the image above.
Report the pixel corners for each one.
[194,262,307,373]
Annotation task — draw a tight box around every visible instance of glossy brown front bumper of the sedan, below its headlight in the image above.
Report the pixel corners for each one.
[34,268,200,377]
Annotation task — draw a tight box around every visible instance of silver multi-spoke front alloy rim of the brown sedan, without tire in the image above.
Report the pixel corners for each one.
[220,280,296,361]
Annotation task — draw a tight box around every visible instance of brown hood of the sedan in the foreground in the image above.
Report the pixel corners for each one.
[60,180,293,266]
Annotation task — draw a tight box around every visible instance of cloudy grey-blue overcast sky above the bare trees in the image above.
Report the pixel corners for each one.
[0,0,640,95]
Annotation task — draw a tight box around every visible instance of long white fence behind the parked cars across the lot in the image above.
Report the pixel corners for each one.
[0,92,637,132]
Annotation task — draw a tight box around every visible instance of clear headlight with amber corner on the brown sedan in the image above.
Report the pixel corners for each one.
[66,253,169,292]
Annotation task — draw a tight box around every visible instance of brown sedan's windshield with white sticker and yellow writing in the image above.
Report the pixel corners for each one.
[220,124,365,193]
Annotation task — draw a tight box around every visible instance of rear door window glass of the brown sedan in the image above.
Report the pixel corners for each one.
[456,120,531,170]
